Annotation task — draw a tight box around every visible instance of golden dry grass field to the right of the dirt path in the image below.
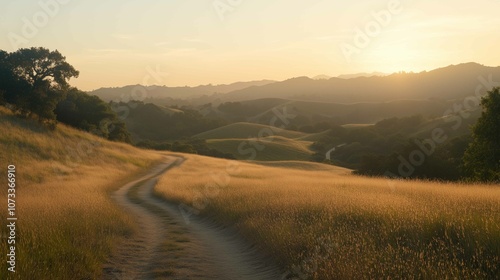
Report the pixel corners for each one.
[156,156,500,279]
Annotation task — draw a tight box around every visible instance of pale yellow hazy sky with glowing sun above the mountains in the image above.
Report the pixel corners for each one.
[0,0,500,90]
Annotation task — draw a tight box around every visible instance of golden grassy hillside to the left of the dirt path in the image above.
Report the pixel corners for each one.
[0,107,161,279]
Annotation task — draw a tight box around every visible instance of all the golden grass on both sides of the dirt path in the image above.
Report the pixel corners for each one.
[0,104,500,279]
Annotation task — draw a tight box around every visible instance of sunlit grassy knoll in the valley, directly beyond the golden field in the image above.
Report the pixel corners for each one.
[207,136,313,161]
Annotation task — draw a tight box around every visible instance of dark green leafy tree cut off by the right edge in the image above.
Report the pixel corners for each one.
[464,88,500,182]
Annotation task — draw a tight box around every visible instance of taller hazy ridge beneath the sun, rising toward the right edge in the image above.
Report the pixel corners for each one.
[221,63,500,103]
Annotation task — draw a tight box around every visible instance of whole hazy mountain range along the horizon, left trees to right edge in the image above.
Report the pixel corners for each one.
[90,63,500,106]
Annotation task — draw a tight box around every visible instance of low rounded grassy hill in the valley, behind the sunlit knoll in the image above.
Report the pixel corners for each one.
[194,122,306,139]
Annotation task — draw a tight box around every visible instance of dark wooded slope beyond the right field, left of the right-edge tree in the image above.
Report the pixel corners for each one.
[311,116,470,180]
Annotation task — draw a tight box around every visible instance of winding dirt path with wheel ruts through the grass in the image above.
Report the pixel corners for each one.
[103,156,280,280]
